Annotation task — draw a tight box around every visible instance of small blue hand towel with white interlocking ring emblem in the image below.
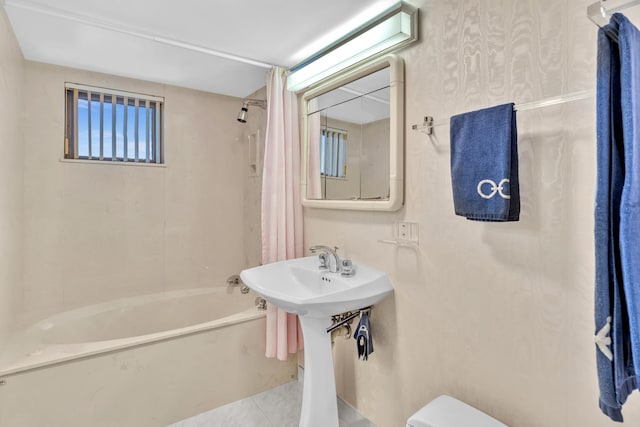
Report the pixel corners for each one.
[450,104,520,221]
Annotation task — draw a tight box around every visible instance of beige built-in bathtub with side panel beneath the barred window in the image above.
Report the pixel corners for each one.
[0,288,297,427]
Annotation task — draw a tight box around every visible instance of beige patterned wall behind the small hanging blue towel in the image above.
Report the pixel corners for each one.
[304,0,640,427]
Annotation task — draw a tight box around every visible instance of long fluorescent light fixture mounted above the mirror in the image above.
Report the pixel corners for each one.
[287,1,418,92]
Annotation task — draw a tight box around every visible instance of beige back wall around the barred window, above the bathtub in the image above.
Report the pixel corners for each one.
[23,62,247,324]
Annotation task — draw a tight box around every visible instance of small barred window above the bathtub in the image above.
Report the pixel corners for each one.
[64,83,164,163]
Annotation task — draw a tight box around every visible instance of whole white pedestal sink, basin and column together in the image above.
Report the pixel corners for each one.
[240,256,393,427]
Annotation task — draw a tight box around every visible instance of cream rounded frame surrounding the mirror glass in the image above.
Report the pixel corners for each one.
[300,55,404,211]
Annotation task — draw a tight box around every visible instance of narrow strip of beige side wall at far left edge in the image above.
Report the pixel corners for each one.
[0,8,24,348]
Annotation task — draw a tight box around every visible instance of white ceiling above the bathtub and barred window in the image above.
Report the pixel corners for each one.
[0,0,397,98]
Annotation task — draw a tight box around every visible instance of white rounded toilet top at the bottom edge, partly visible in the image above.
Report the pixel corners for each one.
[407,395,507,427]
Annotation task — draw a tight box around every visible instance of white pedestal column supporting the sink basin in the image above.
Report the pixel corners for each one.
[299,316,338,427]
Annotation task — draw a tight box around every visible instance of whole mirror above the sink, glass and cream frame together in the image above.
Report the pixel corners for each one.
[301,55,404,211]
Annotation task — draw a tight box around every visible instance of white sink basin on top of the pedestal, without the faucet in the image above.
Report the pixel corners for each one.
[240,256,393,317]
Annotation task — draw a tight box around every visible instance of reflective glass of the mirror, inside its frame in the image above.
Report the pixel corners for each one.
[307,67,390,200]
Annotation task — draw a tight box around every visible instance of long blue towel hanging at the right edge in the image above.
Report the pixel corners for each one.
[594,14,640,422]
